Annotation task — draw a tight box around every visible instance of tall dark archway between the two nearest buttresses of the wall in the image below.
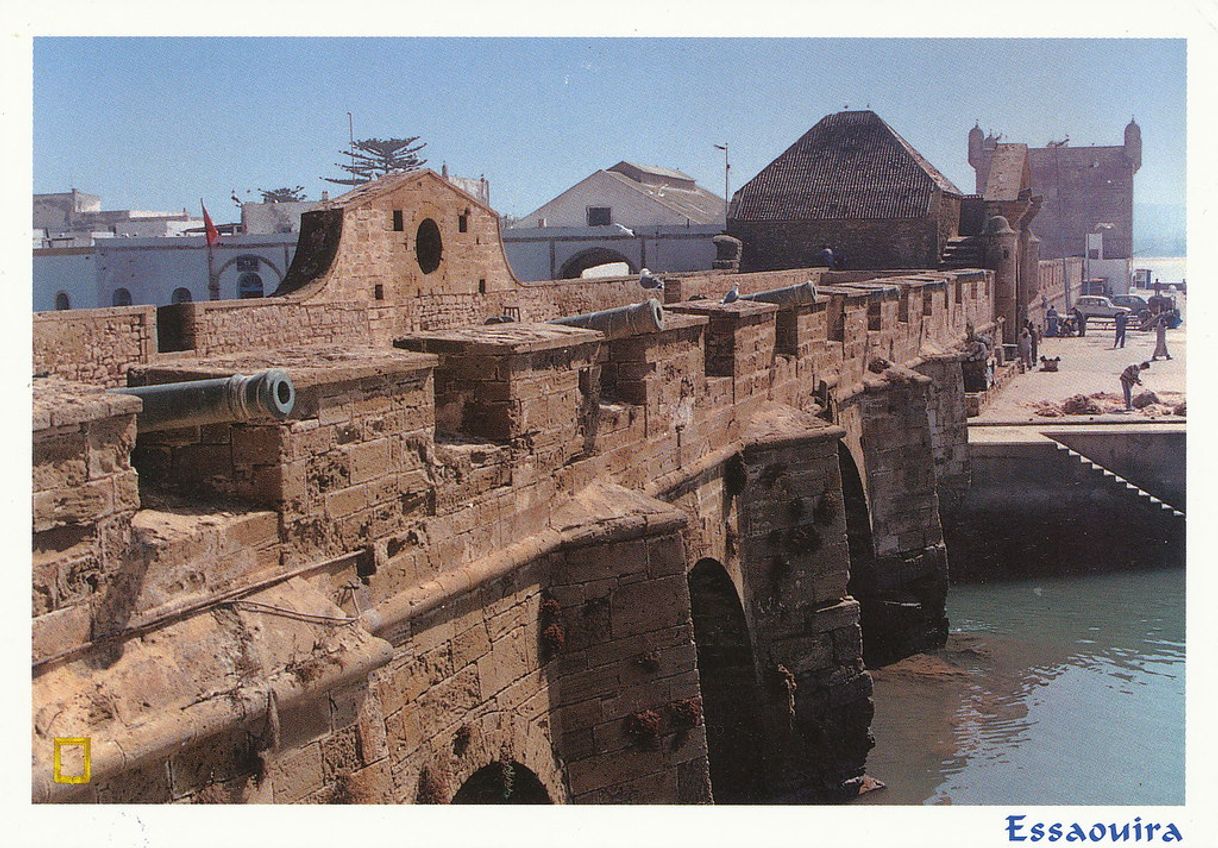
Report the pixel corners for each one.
[688,559,765,804]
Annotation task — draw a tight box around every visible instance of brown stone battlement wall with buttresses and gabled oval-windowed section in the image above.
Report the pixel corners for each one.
[32,172,995,803]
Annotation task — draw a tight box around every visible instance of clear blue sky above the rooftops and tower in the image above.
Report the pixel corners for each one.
[33,38,1185,221]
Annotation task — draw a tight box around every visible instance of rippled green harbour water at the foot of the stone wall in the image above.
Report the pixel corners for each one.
[855,569,1184,805]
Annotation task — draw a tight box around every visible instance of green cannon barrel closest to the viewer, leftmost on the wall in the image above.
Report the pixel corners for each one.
[110,368,296,431]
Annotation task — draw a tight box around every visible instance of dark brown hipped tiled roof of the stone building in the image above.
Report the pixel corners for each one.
[728,111,961,221]
